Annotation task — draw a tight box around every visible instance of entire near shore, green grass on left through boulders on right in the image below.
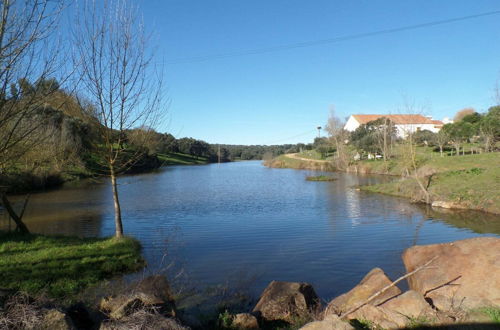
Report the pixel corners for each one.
[0,234,500,330]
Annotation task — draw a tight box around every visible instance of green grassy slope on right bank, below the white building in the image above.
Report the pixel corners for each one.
[361,153,500,214]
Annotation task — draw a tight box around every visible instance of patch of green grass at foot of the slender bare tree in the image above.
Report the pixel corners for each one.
[0,233,145,298]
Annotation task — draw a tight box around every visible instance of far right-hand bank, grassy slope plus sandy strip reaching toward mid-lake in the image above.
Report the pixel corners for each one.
[264,152,500,214]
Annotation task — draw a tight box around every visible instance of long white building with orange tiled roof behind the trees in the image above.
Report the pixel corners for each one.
[344,115,443,137]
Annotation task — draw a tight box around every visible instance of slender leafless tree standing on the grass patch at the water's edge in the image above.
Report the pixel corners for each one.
[74,0,164,237]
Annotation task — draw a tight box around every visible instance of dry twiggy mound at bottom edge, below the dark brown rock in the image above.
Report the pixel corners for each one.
[99,311,189,330]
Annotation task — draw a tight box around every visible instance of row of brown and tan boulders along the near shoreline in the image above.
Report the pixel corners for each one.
[0,237,500,330]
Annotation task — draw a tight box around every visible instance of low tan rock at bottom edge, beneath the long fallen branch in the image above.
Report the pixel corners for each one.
[347,305,408,329]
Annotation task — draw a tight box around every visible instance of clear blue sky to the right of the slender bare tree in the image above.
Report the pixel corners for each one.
[139,0,500,144]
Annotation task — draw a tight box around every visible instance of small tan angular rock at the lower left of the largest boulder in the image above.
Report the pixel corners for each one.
[380,290,436,319]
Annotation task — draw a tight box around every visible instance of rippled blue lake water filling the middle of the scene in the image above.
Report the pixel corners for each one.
[0,161,500,300]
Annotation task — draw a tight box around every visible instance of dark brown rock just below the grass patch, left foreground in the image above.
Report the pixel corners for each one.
[99,275,176,320]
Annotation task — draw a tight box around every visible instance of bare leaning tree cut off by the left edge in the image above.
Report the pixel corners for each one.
[0,0,67,233]
